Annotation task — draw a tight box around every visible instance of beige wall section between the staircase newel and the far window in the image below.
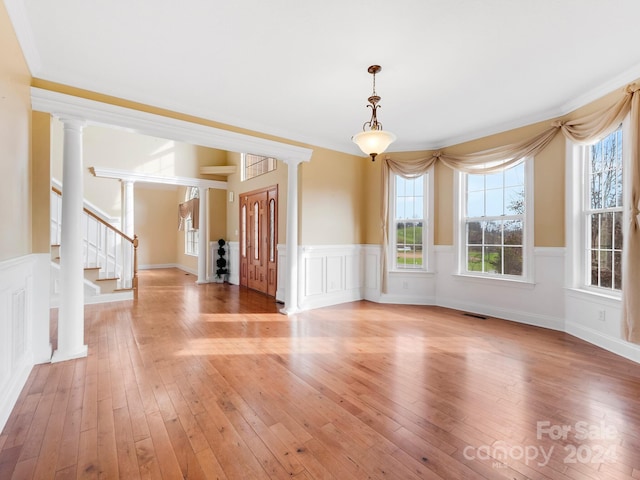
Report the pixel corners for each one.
[134,185,178,265]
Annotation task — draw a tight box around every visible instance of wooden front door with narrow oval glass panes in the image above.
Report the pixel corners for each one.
[240,185,278,296]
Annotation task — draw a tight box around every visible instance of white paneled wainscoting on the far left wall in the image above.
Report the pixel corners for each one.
[0,254,51,431]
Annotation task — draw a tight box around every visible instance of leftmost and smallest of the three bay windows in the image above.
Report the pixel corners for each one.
[389,169,433,271]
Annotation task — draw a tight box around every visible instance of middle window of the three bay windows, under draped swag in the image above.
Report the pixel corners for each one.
[459,159,532,279]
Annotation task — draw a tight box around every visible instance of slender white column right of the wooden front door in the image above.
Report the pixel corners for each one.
[280,160,300,315]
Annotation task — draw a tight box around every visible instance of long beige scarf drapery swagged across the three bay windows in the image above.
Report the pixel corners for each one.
[381,83,640,343]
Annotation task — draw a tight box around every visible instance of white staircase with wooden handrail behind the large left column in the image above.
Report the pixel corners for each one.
[50,182,138,306]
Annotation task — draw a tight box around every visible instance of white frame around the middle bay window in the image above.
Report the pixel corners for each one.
[454,157,535,283]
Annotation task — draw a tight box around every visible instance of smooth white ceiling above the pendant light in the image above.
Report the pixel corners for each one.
[4,0,640,154]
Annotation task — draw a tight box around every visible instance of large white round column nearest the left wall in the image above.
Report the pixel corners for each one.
[51,118,87,362]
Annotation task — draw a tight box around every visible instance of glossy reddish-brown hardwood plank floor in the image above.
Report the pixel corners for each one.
[0,270,640,480]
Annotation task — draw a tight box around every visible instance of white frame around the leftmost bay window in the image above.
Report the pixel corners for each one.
[387,166,435,273]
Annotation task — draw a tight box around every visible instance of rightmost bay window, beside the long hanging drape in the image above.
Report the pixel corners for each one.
[581,128,623,290]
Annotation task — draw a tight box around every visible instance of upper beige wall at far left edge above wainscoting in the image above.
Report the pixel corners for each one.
[0,3,32,261]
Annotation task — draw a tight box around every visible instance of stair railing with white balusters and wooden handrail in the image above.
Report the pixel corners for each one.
[50,186,138,298]
